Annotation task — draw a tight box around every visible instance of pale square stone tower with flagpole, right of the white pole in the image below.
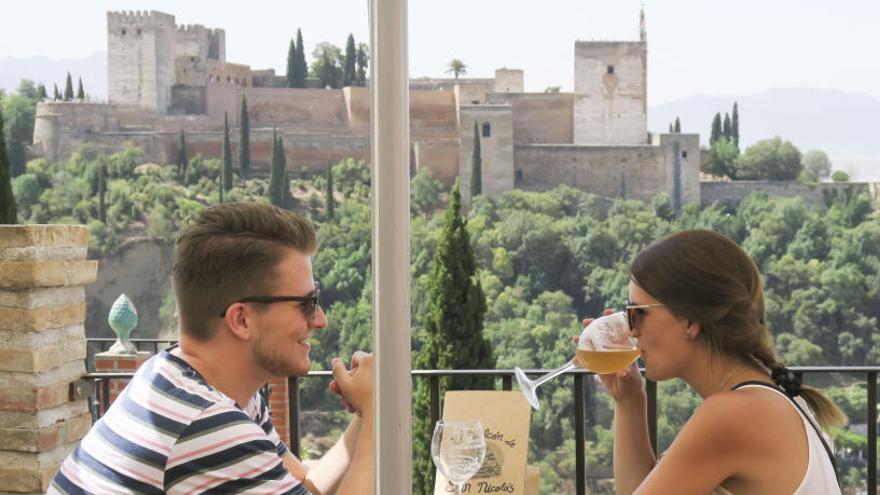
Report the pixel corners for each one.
[574,40,648,145]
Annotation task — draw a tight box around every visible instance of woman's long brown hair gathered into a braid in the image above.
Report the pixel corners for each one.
[630,230,846,428]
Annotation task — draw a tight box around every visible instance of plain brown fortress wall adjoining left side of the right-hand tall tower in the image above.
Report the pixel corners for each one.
[487,93,574,144]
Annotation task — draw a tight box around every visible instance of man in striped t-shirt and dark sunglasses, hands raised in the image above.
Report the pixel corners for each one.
[49,203,373,495]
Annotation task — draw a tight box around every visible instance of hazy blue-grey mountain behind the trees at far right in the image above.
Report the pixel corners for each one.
[648,88,880,181]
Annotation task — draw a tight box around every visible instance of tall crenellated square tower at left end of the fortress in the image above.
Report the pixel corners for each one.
[107,11,177,115]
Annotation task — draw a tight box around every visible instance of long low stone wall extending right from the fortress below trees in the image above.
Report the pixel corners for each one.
[700,180,880,208]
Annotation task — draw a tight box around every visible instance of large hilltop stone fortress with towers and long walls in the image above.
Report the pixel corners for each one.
[33,11,877,208]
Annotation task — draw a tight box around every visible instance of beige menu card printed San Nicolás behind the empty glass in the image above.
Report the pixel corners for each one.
[434,390,532,495]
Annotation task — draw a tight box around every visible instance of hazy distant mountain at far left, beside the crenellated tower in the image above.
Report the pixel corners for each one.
[0,52,107,100]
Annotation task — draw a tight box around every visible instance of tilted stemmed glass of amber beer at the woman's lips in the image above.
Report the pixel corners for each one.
[513,312,639,410]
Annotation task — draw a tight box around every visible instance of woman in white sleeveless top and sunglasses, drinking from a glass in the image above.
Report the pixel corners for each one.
[600,230,846,495]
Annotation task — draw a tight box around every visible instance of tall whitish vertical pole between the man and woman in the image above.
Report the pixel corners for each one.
[370,0,412,495]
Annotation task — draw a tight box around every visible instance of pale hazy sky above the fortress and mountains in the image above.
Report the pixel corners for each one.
[0,0,880,105]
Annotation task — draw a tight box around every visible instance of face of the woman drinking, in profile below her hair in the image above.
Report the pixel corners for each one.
[629,281,696,381]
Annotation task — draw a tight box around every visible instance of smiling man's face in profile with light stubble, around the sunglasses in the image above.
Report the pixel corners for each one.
[251,249,327,376]
